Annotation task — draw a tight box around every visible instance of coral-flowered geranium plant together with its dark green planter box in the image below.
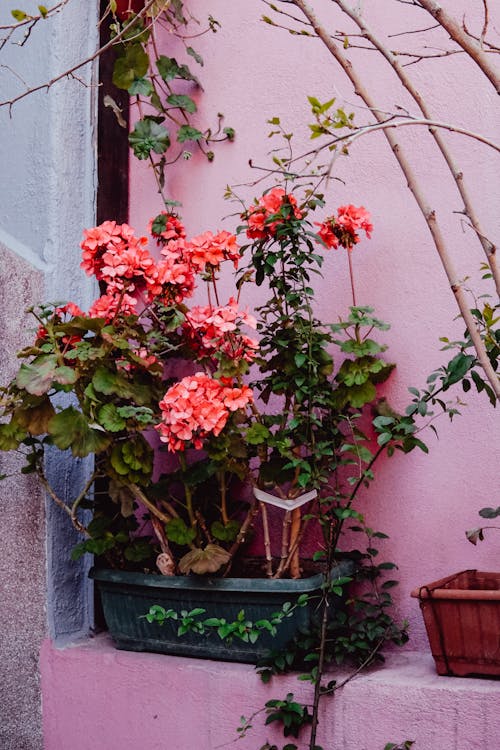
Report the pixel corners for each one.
[0,187,458,660]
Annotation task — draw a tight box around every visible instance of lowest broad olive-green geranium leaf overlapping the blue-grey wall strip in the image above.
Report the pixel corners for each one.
[48,406,111,458]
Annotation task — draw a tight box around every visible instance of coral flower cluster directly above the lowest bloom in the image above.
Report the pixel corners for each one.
[183,298,258,362]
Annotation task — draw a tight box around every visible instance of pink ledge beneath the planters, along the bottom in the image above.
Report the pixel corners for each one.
[41,635,500,750]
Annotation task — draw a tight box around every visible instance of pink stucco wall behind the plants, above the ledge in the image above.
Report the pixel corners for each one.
[131,0,500,648]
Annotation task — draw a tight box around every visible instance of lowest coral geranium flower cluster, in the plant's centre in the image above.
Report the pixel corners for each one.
[156,372,253,452]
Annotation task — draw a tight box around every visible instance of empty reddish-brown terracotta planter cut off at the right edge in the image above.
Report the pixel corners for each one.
[411,570,500,677]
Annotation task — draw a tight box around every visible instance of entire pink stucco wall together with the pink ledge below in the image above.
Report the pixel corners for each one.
[41,0,500,750]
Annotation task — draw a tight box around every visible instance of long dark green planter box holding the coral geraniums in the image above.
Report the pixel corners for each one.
[90,562,352,664]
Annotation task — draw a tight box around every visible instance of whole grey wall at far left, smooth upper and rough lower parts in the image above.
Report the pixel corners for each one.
[0,0,98,750]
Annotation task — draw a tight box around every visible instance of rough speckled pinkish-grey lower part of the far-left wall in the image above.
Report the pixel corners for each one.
[0,244,47,750]
